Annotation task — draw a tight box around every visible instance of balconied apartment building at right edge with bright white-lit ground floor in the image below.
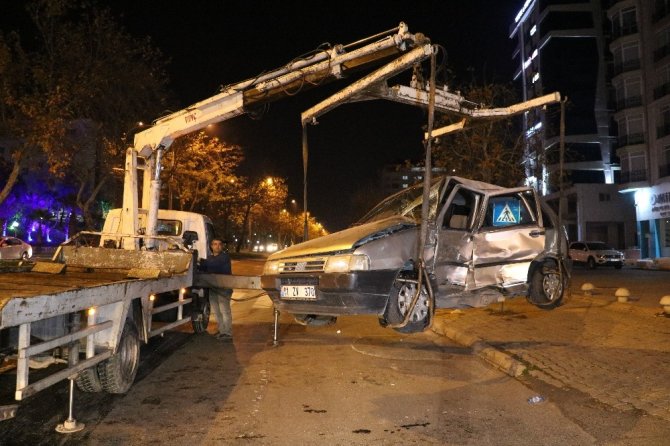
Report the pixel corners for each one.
[607,0,670,258]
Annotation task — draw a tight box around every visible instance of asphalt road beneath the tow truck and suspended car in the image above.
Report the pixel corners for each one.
[0,262,667,445]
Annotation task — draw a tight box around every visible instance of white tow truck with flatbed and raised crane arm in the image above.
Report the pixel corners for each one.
[0,22,568,433]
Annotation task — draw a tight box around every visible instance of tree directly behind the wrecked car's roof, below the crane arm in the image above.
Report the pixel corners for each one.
[433,84,525,187]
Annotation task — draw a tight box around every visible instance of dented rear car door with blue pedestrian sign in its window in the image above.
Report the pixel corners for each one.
[473,189,545,288]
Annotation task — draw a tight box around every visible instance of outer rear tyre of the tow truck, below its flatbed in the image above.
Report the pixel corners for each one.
[98,319,140,393]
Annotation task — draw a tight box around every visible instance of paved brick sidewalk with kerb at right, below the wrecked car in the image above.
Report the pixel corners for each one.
[432,283,670,421]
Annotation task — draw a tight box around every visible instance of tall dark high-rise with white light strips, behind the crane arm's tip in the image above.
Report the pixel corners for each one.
[510,0,640,254]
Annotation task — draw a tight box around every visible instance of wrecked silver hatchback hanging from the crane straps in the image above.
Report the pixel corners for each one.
[261,177,569,333]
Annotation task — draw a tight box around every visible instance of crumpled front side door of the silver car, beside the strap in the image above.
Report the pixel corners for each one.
[434,185,483,294]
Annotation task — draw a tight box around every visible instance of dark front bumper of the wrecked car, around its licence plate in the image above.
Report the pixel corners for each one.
[261,270,397,316]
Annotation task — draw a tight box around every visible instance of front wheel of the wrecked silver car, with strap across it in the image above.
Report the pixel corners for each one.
[382,271,431,333]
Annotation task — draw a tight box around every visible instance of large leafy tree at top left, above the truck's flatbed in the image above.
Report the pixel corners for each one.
[0,0,172,227]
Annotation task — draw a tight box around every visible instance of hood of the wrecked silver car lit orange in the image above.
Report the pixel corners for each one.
[268,215,417,260]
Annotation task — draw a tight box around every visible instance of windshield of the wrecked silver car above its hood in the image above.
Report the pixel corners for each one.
[354,178,443,226]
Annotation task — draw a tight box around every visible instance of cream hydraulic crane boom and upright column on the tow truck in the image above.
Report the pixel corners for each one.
[121,23,428,249]
